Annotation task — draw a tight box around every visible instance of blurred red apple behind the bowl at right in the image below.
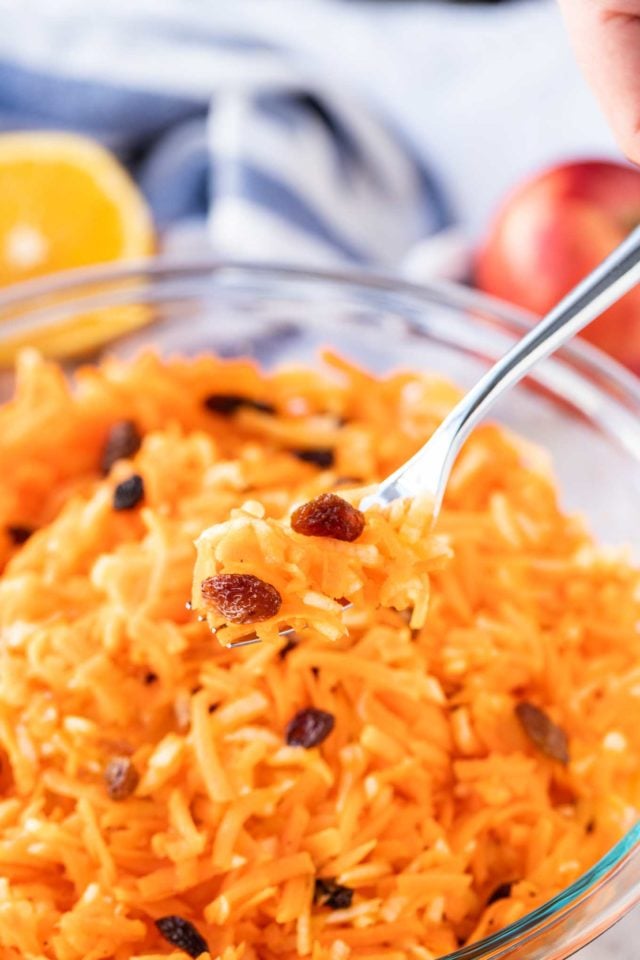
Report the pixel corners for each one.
[474,160,640,373]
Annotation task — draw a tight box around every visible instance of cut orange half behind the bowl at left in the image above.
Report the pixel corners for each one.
[0,131,155,364]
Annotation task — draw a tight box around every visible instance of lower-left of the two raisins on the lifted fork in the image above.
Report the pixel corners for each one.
[201,573,282,623]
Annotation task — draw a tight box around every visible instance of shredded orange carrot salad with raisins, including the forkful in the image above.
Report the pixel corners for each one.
[0,351,640,960]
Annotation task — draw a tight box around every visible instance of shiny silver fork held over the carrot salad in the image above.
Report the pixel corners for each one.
[230,227,640,647]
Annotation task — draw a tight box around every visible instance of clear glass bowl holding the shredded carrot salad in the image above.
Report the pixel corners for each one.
[0,260,640,960]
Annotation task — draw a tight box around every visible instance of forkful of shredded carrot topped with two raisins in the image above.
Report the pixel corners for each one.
[191,491,449,645]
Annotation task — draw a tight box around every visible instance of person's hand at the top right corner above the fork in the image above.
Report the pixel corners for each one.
[559,0,640,164]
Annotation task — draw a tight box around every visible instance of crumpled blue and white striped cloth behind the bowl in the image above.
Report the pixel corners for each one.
[0,0,451,269]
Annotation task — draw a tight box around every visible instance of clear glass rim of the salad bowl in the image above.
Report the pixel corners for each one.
[0,256,640,960]
